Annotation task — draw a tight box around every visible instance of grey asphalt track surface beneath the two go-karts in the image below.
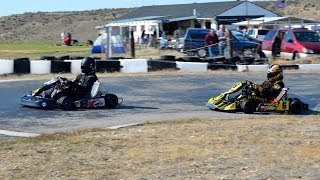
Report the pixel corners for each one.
[0,72,320,139]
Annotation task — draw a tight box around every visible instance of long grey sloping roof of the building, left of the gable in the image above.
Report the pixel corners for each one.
[118,1,243,20]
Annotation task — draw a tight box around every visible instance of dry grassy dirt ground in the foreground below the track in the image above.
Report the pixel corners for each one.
[0,114,320,179]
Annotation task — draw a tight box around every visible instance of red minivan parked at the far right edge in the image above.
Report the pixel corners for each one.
[261,28,320,60]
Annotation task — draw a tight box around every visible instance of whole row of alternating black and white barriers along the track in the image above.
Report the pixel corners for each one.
[0,58,320,74]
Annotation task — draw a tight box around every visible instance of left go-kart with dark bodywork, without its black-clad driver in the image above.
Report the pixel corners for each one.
[20,76,122,110]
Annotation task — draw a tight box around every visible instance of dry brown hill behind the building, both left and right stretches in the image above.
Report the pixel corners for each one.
[0,0,320,43]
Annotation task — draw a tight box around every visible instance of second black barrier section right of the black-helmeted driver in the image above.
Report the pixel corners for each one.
[148,59,177,72]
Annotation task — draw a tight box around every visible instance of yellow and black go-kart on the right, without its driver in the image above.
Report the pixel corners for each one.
[206,81,309,114]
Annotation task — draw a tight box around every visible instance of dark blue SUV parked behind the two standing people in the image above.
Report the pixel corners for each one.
[182,28,259,57]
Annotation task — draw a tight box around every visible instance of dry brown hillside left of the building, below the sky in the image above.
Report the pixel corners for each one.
[0,9,131,43]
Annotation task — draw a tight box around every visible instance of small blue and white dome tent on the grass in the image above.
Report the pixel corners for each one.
[91,33,125,53]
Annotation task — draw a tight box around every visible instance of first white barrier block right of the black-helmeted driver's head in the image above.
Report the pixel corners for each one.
[119,59,148,73]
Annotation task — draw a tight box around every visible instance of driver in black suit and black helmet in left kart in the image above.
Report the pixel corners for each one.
[32,57,98,100]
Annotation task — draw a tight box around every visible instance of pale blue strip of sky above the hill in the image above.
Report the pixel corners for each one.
[0,0,262,16]
